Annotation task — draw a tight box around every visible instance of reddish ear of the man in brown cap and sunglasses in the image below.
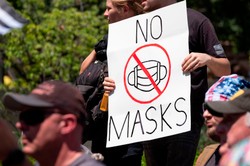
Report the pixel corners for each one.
[59,114,77,134]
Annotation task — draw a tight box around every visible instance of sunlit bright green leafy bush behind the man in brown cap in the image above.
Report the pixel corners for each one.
[0,0,107,92]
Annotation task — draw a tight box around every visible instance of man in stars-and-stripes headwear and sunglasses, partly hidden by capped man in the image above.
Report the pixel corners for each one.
[195,74,250,166]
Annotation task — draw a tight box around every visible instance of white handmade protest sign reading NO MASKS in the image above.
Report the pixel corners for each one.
[107,1,191,147]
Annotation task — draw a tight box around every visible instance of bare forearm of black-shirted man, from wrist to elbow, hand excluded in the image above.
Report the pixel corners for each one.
[207,56,231,77]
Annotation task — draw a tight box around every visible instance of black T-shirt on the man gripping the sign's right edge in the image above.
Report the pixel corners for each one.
[187,9,226,125]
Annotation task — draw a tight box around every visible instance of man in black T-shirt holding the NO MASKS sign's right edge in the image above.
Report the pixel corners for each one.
[142,0,231,166]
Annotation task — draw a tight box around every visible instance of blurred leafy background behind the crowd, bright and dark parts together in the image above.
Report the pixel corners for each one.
[0,0,250,164]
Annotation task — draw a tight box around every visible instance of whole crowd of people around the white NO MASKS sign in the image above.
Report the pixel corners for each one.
[0,0,250,166]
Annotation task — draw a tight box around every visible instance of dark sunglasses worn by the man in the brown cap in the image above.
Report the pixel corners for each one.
[19,110,54,126]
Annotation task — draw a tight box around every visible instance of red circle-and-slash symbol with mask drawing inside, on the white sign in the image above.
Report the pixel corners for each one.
[123,44,171,104]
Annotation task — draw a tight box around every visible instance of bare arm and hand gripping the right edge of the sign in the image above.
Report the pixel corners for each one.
[182,52,231,77]
